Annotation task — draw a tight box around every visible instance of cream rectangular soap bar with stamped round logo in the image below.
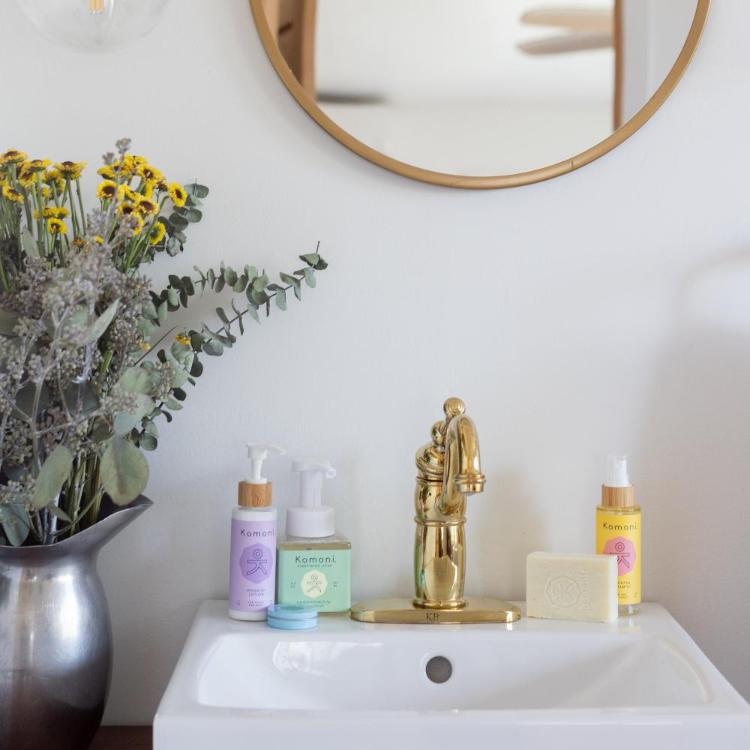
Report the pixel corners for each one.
[526,552,617,622]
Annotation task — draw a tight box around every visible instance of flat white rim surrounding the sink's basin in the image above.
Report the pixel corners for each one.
[155,600,750,726]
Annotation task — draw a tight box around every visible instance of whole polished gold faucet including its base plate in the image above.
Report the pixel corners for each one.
[352,398,521,624]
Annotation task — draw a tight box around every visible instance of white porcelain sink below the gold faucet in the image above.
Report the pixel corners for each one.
[154,601,750,750]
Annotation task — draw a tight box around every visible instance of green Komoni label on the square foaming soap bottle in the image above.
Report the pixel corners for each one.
[276,548,352,612]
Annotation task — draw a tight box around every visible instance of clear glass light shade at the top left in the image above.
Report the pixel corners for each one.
[16,0,169,52]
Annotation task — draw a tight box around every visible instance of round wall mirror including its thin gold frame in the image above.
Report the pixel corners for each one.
[250,0,710,188]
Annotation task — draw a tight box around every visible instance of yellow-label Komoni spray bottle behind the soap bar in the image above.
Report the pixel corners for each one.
[596,456,641,615]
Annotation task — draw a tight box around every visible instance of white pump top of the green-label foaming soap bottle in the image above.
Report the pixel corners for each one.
[286,458,336,538]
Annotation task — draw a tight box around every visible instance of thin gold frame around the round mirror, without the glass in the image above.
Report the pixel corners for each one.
[250,0,711,190]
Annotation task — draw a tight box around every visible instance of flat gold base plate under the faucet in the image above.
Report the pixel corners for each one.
[351,597,521,625]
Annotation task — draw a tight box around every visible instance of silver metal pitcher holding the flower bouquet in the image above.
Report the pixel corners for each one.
[0,496,152,750]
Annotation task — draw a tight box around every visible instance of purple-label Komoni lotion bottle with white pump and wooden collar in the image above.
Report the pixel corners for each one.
[229,443,284,620]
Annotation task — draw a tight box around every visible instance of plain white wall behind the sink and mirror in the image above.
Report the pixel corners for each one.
[0,0,750,723]
